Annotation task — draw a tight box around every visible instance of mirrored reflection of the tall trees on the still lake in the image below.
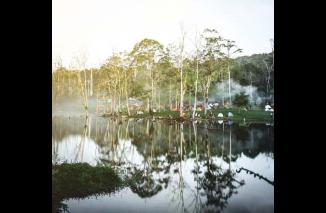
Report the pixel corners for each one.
[53,117,273,212]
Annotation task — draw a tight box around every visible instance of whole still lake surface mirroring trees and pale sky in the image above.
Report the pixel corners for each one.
[52,117,274,212]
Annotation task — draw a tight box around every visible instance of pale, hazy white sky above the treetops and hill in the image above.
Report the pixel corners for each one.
[52,0,274,67]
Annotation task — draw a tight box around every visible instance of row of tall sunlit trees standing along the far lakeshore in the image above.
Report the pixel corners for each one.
[52,29,274,116]
